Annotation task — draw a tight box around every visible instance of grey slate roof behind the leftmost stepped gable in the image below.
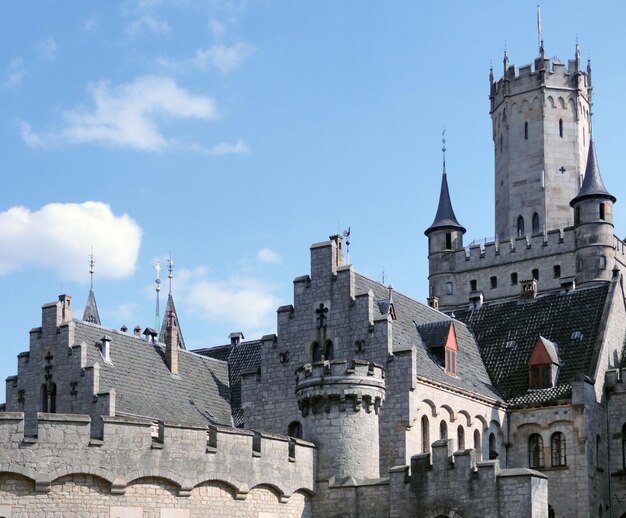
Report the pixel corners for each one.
[75,321,232,426]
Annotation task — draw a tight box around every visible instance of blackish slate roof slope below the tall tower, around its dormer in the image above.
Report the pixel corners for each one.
[455,285,609,406]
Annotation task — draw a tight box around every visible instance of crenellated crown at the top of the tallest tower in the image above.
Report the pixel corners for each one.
[490,54,591,111]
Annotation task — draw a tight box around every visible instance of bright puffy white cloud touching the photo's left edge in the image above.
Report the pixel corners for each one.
[0,201,141,281]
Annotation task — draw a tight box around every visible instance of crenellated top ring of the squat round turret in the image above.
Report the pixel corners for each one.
[296,360,385,416]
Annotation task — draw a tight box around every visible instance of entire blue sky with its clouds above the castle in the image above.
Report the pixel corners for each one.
[0,0,626,401]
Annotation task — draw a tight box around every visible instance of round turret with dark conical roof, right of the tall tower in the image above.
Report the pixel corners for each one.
[570,141,616,285]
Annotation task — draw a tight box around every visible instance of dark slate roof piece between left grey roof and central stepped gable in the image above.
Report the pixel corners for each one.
[193,340,261,427]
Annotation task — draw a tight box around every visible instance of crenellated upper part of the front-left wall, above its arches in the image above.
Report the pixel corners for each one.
[0,412,316,499]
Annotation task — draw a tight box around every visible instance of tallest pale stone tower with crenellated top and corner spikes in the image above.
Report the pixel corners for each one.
[489,43,591,242]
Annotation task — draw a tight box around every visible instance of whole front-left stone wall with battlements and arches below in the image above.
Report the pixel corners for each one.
[0,412,315,518]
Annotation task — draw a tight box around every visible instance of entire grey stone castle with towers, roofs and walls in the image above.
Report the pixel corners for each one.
[0,35,626,518]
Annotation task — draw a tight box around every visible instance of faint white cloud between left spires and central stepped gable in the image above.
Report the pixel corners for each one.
[176,267,278,330]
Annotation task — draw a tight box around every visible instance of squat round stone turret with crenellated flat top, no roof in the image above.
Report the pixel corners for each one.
[296,360,385,480]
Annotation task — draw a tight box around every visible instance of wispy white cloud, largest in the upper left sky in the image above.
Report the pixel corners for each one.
[22,76,217,151]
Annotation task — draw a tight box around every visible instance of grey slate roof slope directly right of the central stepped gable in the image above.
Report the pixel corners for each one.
[355,274,502,401]
